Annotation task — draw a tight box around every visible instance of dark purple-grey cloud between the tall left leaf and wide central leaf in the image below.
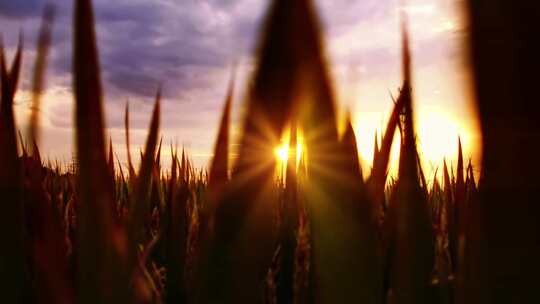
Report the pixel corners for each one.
[87,1,260,97]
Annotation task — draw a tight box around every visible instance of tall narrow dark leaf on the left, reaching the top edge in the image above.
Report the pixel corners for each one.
[73,0,130,303]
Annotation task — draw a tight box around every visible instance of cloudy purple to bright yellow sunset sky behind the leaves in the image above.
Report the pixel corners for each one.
[0,0,481,179]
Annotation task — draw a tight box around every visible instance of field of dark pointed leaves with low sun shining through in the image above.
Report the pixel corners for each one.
[0,0,539,304]
